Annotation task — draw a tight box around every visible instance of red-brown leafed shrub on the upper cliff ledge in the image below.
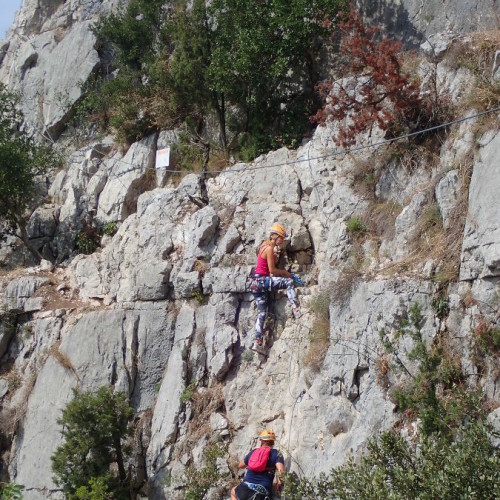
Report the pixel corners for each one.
[312,9,421,147]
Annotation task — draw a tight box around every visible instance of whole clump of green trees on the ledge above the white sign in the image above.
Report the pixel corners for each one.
[80,0,346,155]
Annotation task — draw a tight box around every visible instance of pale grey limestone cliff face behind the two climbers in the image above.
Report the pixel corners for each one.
[0,0,500,500]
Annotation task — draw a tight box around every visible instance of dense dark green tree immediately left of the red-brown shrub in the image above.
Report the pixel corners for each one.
[171,0,345,153]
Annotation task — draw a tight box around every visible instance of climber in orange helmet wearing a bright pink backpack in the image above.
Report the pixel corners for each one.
[231,429,285,500]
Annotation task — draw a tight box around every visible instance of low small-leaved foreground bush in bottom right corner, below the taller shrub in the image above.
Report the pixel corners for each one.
[285,422,500,500]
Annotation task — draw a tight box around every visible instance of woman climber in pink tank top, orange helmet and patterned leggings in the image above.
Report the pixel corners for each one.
[251,224,300,350]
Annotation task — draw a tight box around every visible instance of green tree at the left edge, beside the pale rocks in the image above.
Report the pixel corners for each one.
[0,84,59,262]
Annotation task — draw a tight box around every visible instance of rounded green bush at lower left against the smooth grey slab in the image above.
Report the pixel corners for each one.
[52,387,132,499]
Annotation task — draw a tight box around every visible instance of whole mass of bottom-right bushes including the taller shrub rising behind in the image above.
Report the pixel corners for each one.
[285,303,500,500]
